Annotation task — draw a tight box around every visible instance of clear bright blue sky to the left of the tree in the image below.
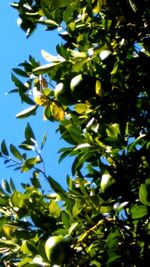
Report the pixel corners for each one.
[0,0,71,192]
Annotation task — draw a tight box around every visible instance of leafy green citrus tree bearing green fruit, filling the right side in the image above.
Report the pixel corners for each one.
[0,0,150,267]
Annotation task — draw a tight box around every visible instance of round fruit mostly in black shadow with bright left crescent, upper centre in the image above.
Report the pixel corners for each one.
[70,74,96,101]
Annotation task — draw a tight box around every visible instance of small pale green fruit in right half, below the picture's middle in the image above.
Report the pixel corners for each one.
[100,173,116,193]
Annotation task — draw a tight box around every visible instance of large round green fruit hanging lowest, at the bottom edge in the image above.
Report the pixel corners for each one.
[45,236,68,266]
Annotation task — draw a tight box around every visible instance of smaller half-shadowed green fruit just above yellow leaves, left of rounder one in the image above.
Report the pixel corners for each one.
[54,83,76,106]
